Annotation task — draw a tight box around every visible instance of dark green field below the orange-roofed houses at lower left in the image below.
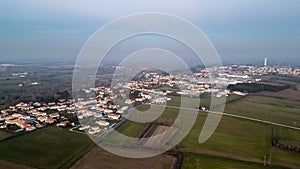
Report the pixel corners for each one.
[0,127,93,169]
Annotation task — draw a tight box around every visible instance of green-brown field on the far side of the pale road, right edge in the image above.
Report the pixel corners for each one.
[225,95,300,127]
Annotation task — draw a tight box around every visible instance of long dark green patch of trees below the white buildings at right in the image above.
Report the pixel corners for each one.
[227,83,291,93]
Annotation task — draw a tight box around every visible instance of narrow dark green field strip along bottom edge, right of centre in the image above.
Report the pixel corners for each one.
[181,153,281,169]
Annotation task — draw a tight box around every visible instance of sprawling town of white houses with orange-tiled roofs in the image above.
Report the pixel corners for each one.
[0,65,300,135]
